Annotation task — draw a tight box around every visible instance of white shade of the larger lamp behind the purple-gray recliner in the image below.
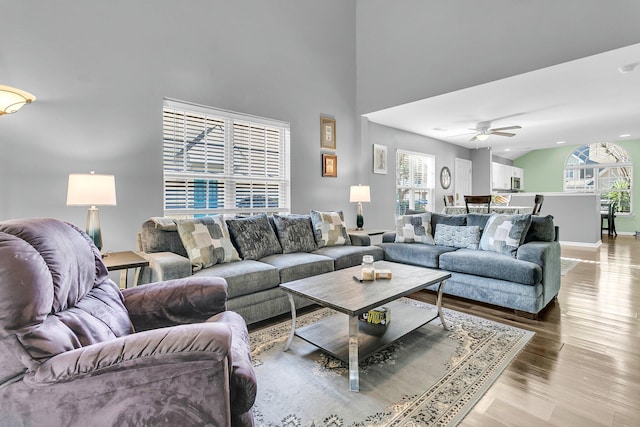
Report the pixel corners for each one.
[67,173,116,206]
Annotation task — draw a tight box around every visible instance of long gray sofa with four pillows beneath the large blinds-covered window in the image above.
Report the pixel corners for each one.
[138,211,383,324]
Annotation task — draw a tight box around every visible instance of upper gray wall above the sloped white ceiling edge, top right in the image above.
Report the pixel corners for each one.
[357,0,640,115]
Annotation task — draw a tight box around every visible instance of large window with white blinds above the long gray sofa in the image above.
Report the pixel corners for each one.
[162,99,290,217]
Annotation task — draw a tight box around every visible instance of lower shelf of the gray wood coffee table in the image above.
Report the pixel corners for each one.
[295,301,438,363]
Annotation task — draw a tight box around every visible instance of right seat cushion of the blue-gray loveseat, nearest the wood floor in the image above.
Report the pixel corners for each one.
[440,249,542,285]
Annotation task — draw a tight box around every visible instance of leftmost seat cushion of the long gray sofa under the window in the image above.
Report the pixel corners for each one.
[193,260,280,299]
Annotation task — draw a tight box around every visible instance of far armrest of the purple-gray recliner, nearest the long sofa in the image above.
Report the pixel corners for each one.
[122,277,227,331]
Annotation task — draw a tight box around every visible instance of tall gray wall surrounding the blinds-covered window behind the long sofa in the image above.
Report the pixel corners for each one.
[0,0,360,250]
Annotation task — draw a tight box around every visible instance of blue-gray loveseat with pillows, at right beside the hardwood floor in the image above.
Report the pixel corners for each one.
[379,213,560,318]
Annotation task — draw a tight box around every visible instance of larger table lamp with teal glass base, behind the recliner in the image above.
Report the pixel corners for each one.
[67,171,116,250]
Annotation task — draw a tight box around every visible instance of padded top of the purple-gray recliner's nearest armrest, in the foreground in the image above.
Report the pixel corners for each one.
[24,323,232,386]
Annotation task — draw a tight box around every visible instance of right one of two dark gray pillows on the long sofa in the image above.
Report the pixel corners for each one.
[227,213,282,260]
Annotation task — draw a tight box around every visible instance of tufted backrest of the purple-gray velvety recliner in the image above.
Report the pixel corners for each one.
[0,219,131,379]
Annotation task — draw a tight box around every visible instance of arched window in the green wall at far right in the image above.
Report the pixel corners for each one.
[564,142,633,214]
